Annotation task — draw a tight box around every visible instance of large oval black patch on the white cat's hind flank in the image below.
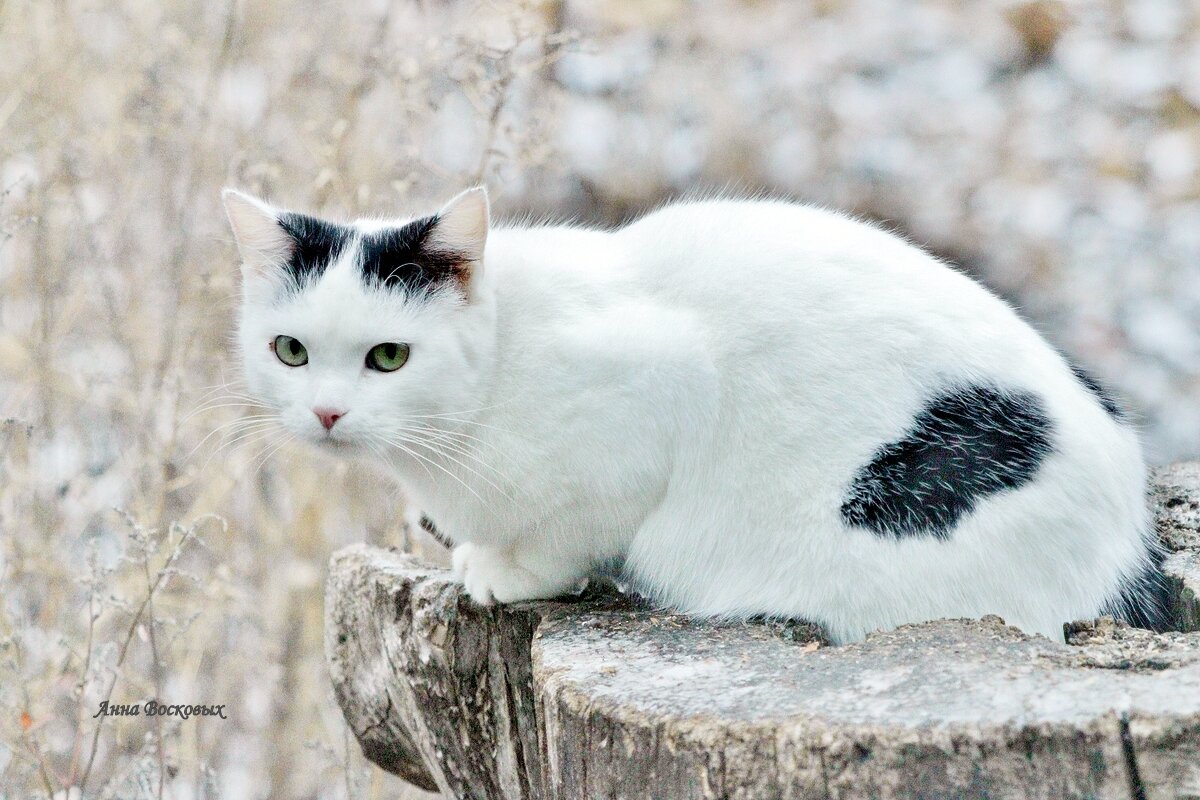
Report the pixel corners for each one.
[841,386,1051,540]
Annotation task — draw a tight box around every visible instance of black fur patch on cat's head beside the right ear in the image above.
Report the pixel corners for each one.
[360,216,469,296]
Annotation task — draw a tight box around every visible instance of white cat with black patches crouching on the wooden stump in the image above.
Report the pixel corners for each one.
[224,188,1166,643]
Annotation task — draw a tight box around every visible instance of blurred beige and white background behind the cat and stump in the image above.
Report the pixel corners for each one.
[0,0,1200,799]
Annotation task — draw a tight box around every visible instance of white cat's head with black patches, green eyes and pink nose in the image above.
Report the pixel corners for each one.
[224,188,491,455]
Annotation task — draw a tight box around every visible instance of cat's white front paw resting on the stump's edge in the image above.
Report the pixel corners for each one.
[451,542,586,606]
